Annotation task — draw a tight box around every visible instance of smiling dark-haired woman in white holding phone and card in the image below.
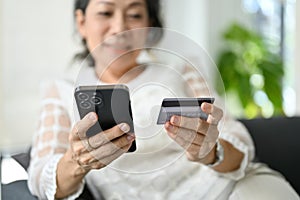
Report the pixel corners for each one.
[11,0,297,199]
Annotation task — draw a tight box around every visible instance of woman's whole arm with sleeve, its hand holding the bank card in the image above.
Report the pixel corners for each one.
[165,66,254,175]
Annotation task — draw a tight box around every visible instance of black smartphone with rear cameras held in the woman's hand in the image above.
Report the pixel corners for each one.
[74,84,136,152]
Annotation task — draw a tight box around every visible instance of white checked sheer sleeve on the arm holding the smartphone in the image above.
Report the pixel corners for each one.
[28,82,84,199]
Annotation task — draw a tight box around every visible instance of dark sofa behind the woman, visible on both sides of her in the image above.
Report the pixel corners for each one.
[1,117,300,200]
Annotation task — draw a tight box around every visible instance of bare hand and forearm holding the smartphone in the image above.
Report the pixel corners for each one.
[55,112,135,198]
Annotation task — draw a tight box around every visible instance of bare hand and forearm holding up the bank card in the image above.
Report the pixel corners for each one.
[165,103,244,173]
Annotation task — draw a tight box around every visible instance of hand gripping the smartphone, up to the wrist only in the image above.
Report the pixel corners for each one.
[69,112,135,171]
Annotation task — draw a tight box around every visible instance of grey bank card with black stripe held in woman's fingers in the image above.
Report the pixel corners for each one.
[157,97,215,124]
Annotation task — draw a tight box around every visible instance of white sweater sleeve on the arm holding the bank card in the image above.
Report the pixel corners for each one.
[183,66,255,180]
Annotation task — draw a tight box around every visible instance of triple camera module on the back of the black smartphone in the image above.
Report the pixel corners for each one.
[77,92,103,109]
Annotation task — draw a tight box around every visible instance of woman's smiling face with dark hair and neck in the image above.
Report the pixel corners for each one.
[75,0,162,82]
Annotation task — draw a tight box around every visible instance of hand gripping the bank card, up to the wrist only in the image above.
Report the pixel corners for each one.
[165,103,223,164]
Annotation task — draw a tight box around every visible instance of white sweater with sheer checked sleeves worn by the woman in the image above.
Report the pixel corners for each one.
[28,64,254,199]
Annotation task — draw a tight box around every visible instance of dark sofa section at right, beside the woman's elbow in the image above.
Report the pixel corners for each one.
[240,117,300,194]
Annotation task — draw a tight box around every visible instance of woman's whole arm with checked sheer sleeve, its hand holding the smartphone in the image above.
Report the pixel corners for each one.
[28,84,134,199]
